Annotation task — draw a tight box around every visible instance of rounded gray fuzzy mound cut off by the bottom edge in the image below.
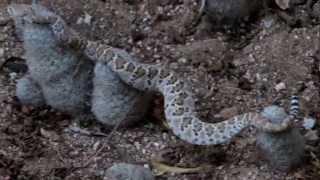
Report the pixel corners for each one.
[103,163,154,180]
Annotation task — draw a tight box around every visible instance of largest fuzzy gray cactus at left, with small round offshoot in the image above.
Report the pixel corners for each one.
[9,3,93,114]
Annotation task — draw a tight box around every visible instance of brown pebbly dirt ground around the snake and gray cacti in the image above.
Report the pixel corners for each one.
[0,0,320,180]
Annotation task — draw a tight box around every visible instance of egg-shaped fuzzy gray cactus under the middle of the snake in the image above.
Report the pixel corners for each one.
[91,62,150,126]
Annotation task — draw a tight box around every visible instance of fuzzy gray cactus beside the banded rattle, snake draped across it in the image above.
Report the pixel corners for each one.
[257,106,305,171]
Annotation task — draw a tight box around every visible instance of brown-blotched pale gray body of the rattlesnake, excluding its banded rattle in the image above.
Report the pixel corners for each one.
[9,5,290,145]
